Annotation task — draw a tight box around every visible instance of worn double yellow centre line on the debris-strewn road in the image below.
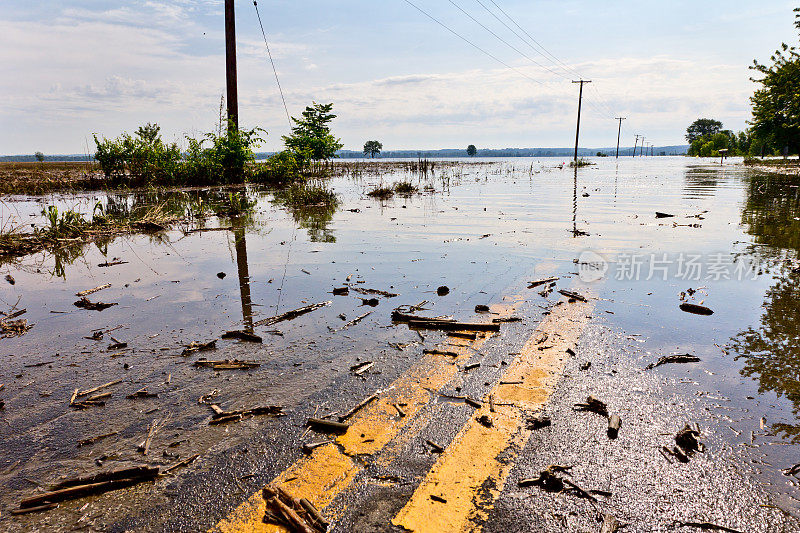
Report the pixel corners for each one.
[212,288,591,533]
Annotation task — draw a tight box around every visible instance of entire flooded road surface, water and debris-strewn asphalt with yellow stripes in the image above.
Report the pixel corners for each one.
[0,158,800,532]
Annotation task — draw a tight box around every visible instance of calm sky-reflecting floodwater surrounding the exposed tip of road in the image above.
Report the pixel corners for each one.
[0,157,800,524]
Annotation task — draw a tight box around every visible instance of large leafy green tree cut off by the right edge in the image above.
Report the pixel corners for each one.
[750,8,800,153]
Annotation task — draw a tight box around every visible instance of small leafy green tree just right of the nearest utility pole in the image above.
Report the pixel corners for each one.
[283,102,343,164]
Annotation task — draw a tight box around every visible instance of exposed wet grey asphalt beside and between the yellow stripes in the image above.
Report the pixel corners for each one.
[9,294,799,532]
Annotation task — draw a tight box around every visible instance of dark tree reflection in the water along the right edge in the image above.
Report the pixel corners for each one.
[732,171,800,443]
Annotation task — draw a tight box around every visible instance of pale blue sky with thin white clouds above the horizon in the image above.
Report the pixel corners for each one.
[0,0,798,155]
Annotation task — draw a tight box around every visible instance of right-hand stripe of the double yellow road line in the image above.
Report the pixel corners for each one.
[392,303,591,533]
